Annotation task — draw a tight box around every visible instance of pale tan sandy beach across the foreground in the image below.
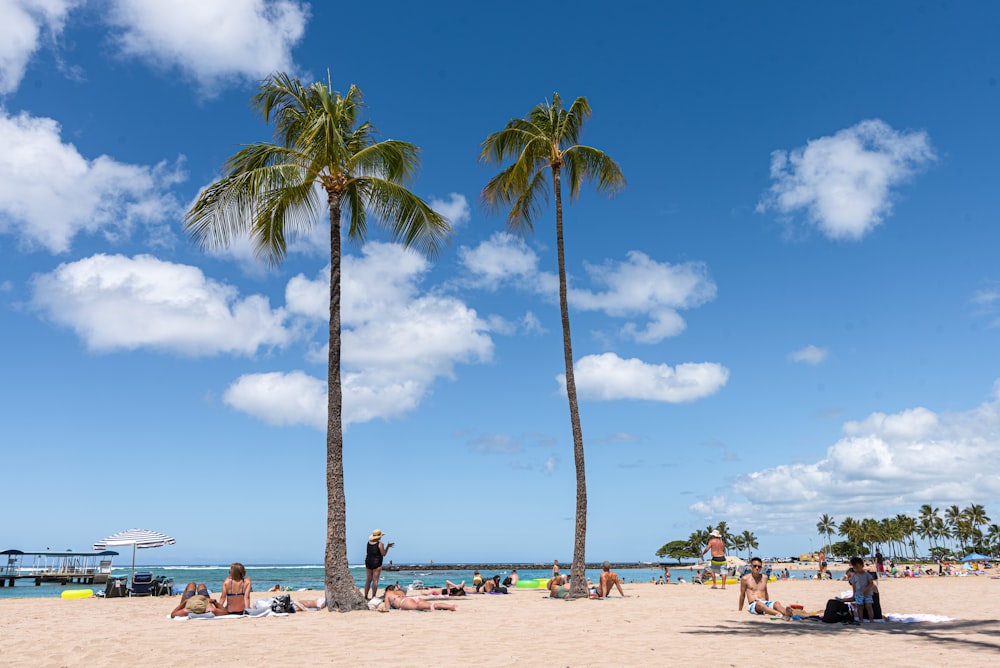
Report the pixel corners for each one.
[0,576,1000,668]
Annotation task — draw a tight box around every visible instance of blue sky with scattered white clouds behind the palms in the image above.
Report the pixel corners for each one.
[0,0,1000,563]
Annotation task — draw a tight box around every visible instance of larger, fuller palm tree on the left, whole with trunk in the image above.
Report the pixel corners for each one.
[185,73,450,612]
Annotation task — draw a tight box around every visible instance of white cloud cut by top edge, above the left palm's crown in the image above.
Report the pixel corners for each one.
[109,0,309,92]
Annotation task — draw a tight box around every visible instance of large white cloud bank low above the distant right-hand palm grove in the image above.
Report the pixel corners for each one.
[691,382,1000,532]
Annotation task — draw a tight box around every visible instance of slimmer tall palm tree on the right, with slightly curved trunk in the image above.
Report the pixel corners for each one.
[479,93,625,596]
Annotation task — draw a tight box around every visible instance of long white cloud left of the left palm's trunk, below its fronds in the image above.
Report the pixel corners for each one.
[33,255,292,356]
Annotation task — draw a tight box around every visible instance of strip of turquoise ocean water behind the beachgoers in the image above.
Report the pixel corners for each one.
[0,564,843,599]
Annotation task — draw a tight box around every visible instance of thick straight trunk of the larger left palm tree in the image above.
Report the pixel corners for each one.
[323,193,364,612]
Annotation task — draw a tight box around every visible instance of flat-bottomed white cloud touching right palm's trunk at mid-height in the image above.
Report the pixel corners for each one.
[568,353,729,403]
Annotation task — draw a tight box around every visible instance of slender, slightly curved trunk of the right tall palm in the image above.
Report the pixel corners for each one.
[552,166,587,597]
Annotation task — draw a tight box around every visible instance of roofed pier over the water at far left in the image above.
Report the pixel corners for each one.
[0,550,118,587]
